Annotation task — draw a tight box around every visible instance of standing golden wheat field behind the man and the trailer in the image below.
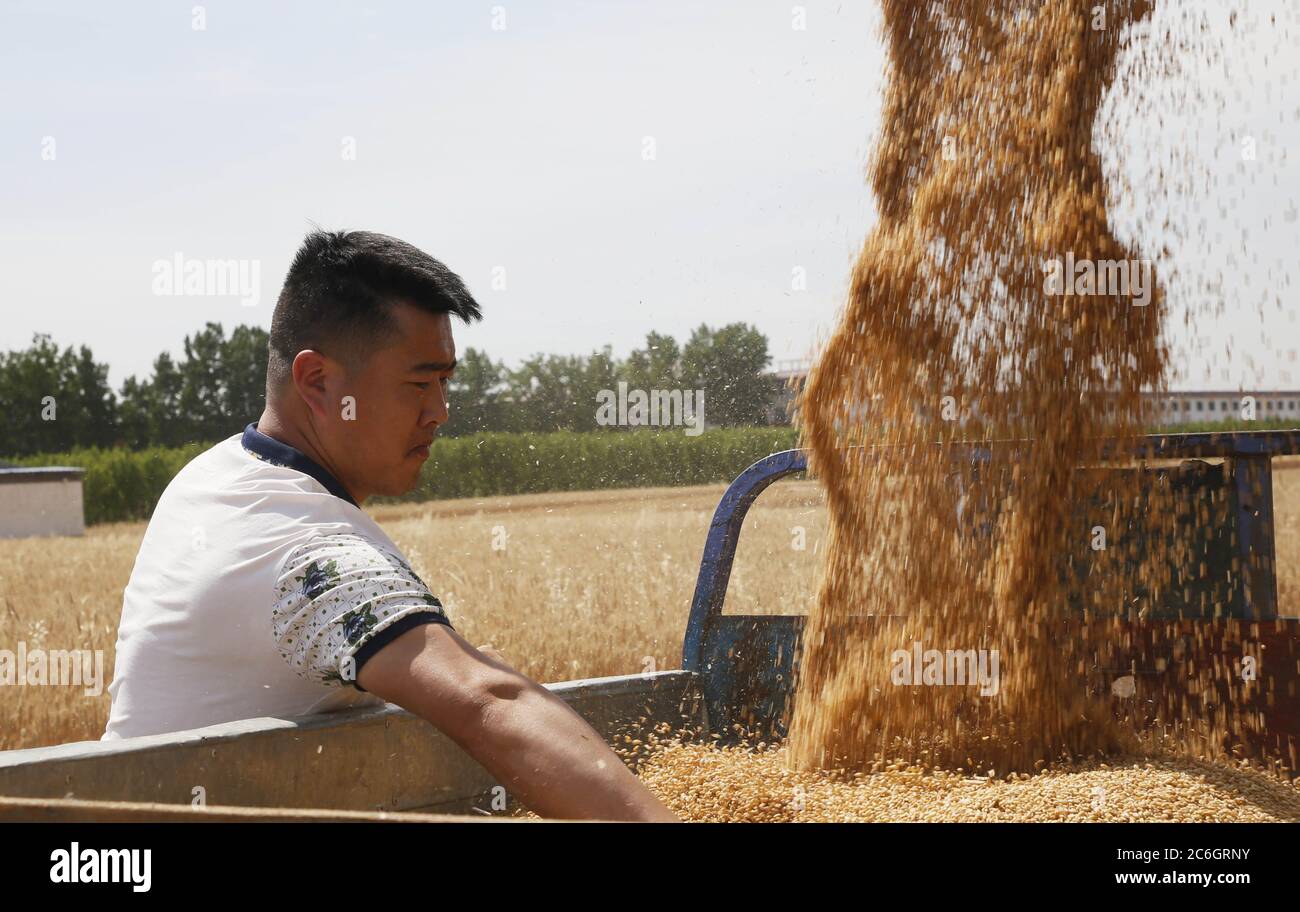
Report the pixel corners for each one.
[0,459,1300,750]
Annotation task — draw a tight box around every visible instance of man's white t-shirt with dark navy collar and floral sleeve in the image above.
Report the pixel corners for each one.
[103,425,450,739]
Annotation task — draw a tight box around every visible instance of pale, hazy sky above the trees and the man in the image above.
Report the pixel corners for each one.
[0,0,1300,387]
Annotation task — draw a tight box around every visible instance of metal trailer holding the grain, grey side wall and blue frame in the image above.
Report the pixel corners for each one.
[0,431,1300,821]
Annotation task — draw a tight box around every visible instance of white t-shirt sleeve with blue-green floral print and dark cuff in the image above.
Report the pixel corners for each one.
[272,533,451,690]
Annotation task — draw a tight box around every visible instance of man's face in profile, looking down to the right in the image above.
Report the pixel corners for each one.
[329,304,456,500]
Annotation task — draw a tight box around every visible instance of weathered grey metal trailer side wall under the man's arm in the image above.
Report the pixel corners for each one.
[0,672,703,813]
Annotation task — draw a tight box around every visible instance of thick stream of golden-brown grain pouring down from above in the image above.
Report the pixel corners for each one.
[788,0,1284,774]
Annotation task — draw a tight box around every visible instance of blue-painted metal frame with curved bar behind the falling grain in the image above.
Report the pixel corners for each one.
[681,430,1300,735]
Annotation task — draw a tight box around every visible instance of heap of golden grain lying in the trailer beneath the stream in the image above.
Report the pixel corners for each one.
[623,726,1300,822]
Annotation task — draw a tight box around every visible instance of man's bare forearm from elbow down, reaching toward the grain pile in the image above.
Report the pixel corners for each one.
[462,673,676,821]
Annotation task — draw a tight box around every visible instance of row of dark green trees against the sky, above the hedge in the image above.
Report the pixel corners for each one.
[0,323,777,456]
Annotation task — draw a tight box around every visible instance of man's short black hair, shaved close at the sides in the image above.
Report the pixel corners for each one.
[267,231,482,391]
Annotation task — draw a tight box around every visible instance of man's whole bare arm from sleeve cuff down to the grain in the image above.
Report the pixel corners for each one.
[358,624,677,821]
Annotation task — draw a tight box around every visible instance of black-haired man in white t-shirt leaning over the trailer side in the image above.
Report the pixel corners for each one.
[104,231,675,821]
